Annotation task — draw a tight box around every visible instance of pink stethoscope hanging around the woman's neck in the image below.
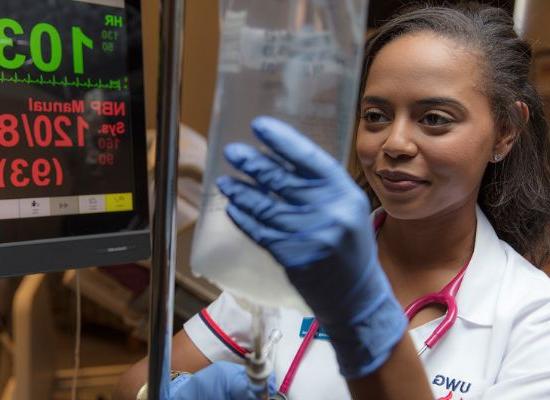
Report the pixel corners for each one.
[270,211,471,400]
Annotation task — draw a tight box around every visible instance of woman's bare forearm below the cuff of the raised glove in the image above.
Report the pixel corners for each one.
[348,334,433,400]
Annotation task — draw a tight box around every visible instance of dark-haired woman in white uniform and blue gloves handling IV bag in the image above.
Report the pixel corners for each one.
[121,6,550,400]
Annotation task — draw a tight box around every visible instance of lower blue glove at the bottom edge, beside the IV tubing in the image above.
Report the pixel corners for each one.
[170,361,275,400]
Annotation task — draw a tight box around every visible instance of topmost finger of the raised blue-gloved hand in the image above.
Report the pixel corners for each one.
[252,117,342,178]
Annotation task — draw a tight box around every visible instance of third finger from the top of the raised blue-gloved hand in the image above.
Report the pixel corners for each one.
[217,176,319,232]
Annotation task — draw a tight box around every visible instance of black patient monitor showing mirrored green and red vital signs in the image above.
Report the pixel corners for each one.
[0,0,150,275]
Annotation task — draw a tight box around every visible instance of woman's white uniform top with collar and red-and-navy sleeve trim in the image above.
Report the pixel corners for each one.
[184,208,550,400]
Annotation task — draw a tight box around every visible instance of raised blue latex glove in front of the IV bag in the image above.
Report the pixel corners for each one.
[217,117,407,378]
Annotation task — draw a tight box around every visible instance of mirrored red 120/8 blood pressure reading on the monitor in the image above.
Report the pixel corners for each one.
[0,114,90,148]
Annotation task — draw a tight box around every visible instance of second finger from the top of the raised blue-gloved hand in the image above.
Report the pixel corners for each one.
[224,143,326,204]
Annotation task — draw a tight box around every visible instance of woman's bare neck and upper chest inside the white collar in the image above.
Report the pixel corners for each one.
[378,201,476,329]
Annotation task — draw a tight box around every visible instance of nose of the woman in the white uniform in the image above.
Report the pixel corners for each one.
[382,117,418,159]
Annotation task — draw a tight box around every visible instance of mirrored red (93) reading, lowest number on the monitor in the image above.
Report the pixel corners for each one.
[0,157,63,189]
